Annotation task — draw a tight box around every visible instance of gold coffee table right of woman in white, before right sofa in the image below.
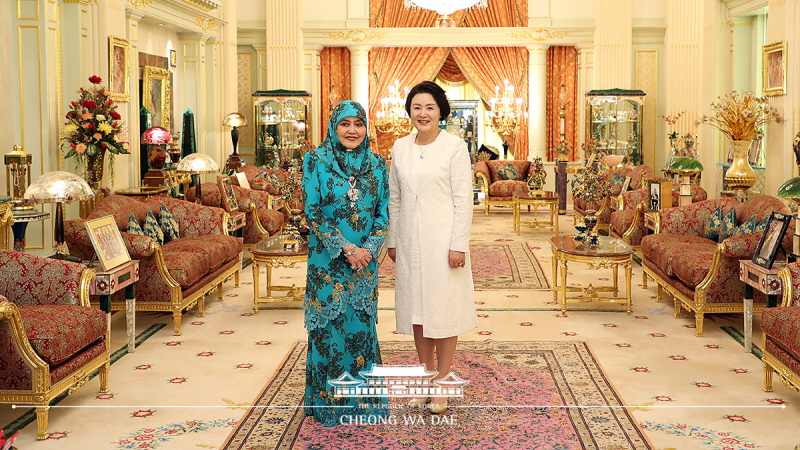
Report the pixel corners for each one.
[550,235,633,315]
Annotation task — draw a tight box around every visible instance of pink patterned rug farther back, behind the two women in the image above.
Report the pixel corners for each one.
[378,242,550,290]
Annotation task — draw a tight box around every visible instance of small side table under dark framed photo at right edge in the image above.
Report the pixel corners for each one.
[739,260,785,353]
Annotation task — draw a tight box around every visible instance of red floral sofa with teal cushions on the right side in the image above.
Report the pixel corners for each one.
[641,195,794,336]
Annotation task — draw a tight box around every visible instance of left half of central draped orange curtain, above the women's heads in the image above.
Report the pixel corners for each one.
[369,47,447,156]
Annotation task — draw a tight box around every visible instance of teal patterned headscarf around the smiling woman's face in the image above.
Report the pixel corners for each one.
[317,100,372,176]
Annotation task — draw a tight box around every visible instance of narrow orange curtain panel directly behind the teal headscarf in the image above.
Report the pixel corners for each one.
[319,47,350,135]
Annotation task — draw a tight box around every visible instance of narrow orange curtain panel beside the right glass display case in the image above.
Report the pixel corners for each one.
[545,47,579,161]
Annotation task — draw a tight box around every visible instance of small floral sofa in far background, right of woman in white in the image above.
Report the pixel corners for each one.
[475,160,532,215]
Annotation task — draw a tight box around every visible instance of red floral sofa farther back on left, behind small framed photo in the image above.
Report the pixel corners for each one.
[186,179,284,248]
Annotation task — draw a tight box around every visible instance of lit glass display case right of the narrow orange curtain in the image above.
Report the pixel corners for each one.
[586,89,646,166]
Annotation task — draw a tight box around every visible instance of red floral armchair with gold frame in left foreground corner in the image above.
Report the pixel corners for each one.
[0,250,110,440]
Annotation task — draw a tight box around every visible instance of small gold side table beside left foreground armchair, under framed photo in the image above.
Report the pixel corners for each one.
[89,259,139,353]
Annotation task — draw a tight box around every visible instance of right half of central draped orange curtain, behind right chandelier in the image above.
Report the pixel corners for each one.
[451,47,528,160]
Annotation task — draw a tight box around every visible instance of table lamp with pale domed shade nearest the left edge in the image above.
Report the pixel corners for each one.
[24,171,94,262]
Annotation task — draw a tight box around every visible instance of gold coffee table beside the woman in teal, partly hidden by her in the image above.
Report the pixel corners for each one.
[250,236,308,314]
